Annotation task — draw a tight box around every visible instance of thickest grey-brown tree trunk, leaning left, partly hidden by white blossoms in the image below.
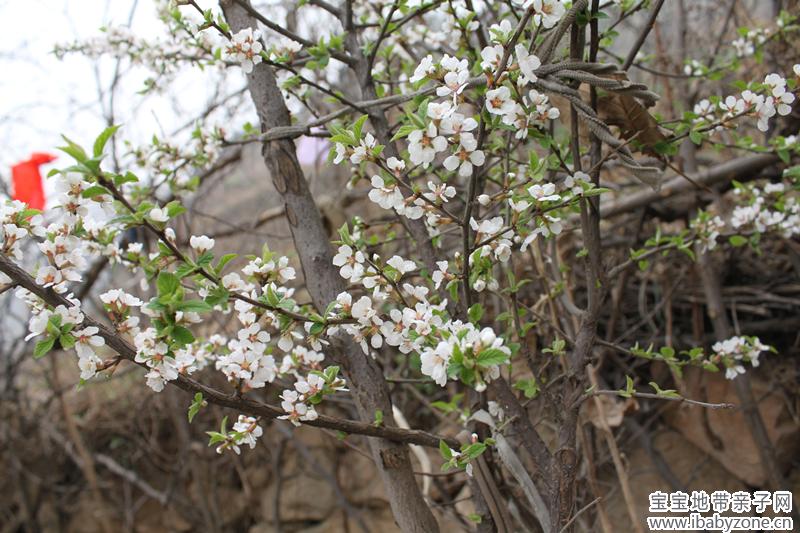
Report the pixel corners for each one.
[220,0,439,533]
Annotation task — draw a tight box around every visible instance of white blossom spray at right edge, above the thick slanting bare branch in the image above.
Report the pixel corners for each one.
[693,65,800,132]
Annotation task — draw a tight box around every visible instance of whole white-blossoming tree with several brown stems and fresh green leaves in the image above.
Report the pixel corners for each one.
[0,0,800,532]
